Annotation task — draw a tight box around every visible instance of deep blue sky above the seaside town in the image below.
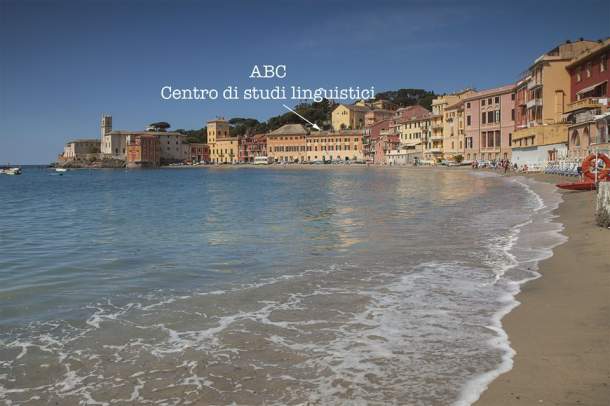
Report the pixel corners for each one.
[0,0,610,164]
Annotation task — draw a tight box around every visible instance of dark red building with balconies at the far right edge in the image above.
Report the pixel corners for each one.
[566,39,610,160]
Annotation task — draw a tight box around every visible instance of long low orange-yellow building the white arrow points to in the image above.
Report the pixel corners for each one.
[305,130,364,162]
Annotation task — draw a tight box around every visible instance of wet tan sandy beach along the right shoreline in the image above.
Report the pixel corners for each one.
[476,175,610,406]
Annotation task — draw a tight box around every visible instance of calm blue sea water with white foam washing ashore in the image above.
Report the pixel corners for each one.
[0,168,561,405]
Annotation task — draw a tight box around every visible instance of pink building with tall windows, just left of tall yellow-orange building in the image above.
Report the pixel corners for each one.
[464,84,515,161]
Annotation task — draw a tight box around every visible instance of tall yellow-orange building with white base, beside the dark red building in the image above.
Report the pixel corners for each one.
[512,40,597,168]
